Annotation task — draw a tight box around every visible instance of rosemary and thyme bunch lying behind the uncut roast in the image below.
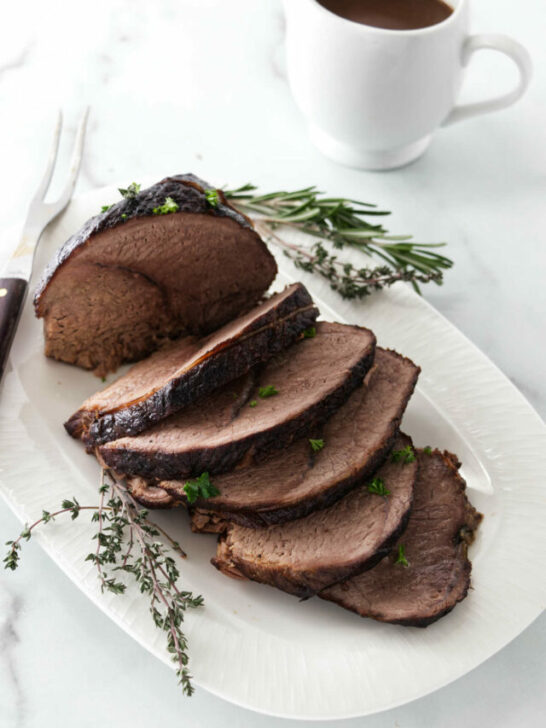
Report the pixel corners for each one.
[223,184,453,299]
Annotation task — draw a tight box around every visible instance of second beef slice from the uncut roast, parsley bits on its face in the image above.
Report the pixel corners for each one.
[97,323,375,480]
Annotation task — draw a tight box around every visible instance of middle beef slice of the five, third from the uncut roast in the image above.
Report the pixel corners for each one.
[142,348,419,516]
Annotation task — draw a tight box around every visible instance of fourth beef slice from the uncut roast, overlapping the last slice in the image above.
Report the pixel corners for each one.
[213,435,417,597]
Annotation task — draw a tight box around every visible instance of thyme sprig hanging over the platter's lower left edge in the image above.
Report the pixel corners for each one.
[4,469,203,695]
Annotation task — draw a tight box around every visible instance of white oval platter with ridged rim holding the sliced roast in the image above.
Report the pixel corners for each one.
[0,188,546,720]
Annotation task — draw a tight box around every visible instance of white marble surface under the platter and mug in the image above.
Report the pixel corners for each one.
[0,0,546,728]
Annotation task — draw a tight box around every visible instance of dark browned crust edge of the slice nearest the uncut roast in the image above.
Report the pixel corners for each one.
[64,284,318,448]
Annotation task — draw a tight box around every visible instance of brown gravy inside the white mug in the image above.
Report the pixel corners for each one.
[318,0,453,30]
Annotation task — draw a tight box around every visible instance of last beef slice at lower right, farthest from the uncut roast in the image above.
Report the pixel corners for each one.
[320,450,482,627]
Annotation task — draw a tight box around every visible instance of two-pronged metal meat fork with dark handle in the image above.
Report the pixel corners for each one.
[0,108,89,380]
